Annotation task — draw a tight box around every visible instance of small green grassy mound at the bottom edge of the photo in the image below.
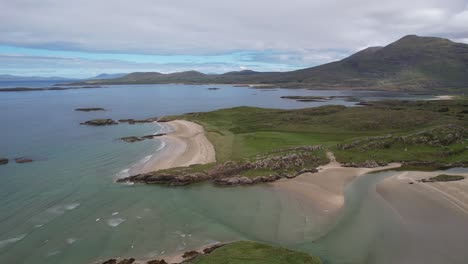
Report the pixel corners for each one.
[192,241,322,264]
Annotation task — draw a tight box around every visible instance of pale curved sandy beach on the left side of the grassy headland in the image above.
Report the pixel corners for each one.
[138,120,216,173]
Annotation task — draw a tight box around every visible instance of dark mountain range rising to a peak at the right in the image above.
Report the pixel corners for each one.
[77,35,468,91]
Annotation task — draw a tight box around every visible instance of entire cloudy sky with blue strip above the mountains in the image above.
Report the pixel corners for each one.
[0,0,468,77]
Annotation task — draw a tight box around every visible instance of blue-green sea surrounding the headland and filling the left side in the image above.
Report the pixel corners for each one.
[0,82,436,264]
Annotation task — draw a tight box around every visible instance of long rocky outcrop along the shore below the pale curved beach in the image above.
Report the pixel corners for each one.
[118,146,322,186]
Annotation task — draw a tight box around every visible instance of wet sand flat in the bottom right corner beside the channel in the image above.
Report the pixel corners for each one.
[377,172,468,264]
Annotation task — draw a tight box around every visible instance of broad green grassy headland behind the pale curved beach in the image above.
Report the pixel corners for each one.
[177,98,468,167]
